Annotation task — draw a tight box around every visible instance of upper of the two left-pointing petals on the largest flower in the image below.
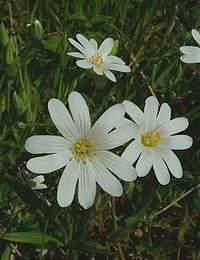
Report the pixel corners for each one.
[25,135,69,154]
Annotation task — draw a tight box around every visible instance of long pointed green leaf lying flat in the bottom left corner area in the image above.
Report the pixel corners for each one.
[2,231,63,246]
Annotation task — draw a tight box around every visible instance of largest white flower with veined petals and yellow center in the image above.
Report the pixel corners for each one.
[25,92,136,209]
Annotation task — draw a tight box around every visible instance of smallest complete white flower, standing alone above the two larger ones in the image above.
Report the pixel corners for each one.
[68,34,131,82]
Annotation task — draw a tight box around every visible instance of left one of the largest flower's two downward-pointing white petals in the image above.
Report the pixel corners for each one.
[57,160,80,207]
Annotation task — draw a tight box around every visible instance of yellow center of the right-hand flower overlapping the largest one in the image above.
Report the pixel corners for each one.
[141,130,161,147]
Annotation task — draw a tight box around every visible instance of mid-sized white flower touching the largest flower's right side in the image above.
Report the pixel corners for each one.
[119,96,192,185]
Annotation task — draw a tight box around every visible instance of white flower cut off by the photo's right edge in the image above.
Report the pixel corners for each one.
[180,29,200,63]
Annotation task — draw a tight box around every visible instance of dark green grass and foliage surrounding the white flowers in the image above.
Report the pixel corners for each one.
[0,0,200,260]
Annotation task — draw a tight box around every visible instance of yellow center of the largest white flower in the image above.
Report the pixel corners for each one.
[73,138,95,161]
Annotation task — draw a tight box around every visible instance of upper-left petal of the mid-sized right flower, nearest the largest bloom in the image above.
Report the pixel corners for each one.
[123,100,145,126]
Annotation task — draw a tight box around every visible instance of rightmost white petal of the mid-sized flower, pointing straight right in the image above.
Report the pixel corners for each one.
[166,135,193,150]
